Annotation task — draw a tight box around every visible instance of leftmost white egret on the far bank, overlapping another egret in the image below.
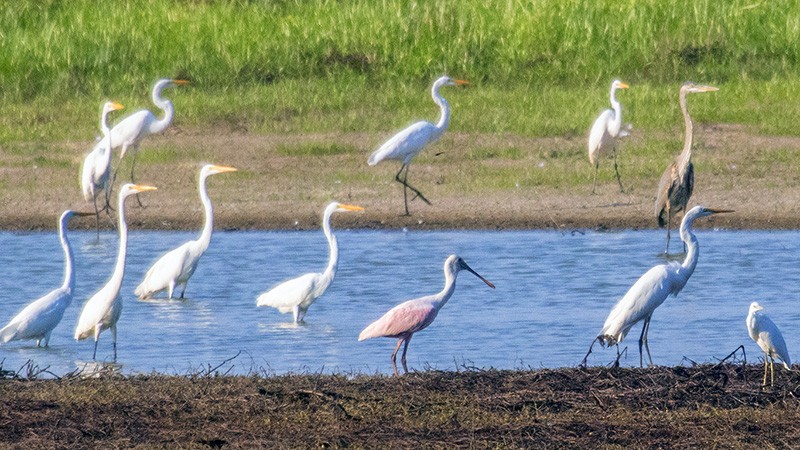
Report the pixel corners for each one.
[81,102,123,237]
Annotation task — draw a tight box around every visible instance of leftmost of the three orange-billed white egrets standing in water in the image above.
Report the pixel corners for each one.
[75,183,156,361]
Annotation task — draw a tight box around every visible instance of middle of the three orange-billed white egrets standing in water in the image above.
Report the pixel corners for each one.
[135,164,236,300]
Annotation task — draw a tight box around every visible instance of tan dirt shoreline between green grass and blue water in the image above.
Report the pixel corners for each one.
[0,125,800,231]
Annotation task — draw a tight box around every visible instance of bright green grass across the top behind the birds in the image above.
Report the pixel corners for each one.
[0,0,800,142]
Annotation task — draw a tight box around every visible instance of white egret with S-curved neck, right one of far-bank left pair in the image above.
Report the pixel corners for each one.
[111,78,189,202]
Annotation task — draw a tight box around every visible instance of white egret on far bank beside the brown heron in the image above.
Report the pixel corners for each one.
[589,80,628,194]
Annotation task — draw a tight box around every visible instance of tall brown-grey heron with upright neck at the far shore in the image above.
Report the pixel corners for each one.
[655,81,719,253]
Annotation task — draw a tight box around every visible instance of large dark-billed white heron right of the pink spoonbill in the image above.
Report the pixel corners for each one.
[581,206,732,366]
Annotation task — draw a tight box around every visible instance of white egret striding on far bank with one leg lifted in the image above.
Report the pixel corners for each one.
[368,76,469,216]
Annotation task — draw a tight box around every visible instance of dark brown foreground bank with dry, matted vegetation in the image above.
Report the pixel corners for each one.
[0,365,800,448]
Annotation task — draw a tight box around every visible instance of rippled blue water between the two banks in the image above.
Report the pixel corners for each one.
[0,230,800,375]
